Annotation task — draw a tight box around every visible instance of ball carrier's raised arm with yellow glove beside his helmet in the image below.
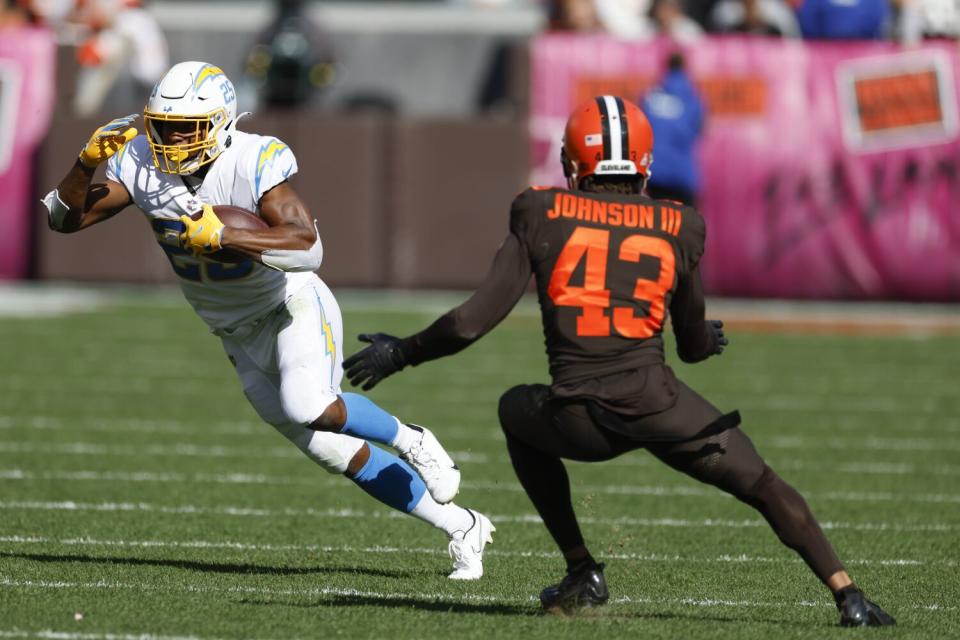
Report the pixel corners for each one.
[43,114,137,233]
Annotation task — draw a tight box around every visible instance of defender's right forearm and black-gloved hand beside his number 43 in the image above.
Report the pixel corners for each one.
[670,267,728,362]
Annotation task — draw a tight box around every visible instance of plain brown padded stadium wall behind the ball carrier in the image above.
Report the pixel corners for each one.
[33,41,530,288]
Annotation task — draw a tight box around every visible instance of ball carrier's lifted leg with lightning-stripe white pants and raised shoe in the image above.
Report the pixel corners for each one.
[278,282,460,503]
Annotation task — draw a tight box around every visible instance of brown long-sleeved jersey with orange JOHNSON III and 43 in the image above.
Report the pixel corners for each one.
[400,188,716,415]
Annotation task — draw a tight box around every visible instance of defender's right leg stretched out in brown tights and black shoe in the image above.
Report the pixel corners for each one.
[648,383,893,624]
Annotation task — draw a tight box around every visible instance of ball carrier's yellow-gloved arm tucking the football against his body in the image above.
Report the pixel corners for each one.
[181,182,323,271]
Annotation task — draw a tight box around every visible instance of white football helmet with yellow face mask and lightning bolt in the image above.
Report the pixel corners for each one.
[143,62,237,175]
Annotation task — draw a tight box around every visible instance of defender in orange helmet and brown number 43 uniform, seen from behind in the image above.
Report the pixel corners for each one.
[344,96,894,625]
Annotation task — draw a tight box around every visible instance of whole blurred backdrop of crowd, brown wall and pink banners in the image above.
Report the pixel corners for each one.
[0,0,960,301]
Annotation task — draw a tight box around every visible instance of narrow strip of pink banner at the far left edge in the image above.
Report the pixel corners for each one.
[0,27,56,278]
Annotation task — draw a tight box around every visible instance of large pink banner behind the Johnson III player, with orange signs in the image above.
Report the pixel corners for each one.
[531,34,960,301]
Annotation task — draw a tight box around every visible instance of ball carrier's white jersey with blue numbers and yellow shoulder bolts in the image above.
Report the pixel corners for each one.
[107,131,316,330]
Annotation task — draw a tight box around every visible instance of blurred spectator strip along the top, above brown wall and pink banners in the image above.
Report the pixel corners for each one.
[0,0,960,117]
